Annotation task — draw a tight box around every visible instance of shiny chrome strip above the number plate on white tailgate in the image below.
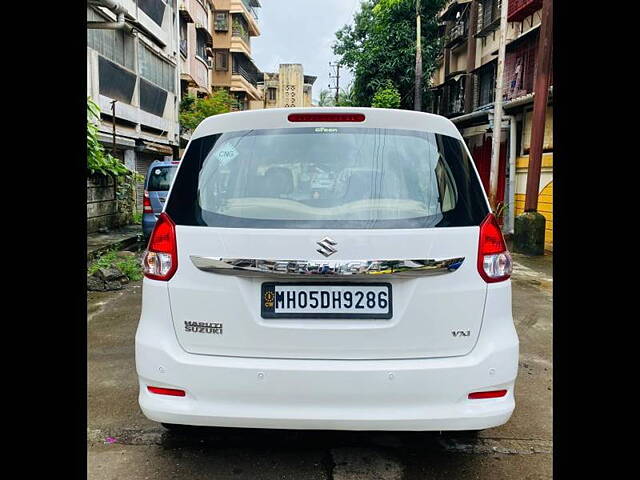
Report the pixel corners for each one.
[190,255,464,278]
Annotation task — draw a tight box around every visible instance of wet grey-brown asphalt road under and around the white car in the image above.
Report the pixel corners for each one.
[87,255,552,480]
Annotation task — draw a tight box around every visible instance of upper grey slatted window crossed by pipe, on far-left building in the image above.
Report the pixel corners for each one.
[87,8,136,72]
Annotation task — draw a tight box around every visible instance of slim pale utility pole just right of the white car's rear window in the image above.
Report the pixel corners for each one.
[489,0,509,209]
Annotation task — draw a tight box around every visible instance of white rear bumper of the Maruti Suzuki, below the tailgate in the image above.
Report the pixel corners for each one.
[135,279,519,431]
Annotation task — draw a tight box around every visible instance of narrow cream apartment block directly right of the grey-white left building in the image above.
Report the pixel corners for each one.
[178,0,213,98]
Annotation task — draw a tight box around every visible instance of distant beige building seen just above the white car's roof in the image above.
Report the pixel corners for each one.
[254,63,317,108]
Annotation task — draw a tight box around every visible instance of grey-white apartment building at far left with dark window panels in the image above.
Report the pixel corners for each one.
[87,0,180,211]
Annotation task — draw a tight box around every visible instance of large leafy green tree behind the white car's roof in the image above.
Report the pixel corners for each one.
[333,0,446,109]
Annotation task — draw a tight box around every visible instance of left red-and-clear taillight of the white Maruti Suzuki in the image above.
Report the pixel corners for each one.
[143,213,178,282]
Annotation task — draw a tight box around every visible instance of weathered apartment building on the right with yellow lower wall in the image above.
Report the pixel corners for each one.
[430,0,553,250]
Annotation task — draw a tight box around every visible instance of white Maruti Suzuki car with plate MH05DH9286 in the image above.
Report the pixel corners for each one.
[135,108,518,431]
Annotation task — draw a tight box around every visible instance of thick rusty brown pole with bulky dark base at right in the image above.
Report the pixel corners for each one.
[513,0,553,255]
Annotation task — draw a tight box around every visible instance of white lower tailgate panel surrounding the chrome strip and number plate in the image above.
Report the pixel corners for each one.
[169,226,487,359]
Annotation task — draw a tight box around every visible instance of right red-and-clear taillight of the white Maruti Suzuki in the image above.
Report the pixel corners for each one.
[478,213,513,283]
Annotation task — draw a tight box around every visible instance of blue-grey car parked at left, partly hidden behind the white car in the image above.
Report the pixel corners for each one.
[142,160,180,238]
